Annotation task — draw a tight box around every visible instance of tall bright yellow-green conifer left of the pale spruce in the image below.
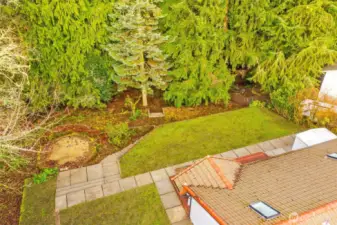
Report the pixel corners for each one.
[21,0,111,109]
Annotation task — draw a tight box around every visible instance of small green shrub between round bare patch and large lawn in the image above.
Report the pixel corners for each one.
[105,123,133,146]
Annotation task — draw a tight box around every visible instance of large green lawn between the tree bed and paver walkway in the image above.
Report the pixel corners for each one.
[121,107,301,177]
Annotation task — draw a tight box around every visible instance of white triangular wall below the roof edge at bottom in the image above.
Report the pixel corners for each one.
[190,198,219,225]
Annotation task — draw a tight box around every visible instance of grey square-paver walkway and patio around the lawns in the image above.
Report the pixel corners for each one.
[55,135,295,225]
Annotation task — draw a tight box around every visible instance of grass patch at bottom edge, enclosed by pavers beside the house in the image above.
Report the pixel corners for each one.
[61,184,170,225]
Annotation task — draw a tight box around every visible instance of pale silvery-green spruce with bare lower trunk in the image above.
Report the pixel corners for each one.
[106,0,168,106]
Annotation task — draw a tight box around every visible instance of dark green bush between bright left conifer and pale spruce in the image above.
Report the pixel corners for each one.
[85,52,117,102]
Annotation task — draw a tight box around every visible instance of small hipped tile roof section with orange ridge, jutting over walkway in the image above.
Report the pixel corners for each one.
[172,156,241,189]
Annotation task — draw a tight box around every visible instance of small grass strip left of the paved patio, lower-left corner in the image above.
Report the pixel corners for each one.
[20,178,56,225]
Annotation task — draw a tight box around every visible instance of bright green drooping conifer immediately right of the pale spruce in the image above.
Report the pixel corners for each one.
[164,0,234,106]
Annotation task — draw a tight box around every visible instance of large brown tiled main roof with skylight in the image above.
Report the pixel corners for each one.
[175,140,337,225]
